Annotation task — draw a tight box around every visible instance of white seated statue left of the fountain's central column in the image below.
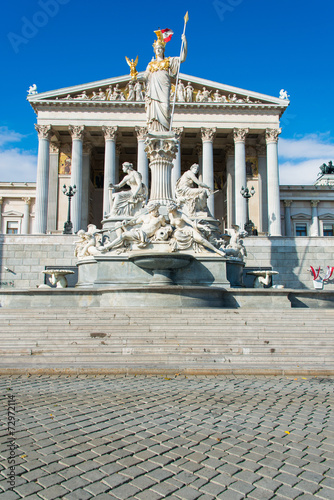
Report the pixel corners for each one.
[108,162,147,217]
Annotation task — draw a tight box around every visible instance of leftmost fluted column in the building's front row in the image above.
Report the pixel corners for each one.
[35,125,51,234]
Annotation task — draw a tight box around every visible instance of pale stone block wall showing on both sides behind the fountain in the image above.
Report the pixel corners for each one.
[0,235,334,291]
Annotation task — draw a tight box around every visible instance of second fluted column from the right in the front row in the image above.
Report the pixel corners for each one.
[233,128,249,230]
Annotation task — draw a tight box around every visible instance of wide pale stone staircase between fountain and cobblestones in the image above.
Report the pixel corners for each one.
[0,307,334,375]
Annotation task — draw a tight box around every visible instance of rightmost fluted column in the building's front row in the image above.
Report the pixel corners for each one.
[266,128,282,236]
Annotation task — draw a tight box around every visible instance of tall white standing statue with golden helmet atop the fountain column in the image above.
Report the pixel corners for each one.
[143,30,187,132]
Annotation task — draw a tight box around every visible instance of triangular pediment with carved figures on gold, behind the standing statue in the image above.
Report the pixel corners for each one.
[27,72,289,110]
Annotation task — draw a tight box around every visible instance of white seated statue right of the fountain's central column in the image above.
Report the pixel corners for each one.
[175,163,212,217]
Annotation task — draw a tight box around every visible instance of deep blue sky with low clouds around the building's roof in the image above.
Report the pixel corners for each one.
[0,0,334,184]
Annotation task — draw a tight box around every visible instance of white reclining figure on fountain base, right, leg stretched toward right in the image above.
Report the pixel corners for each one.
[167,202,225,257]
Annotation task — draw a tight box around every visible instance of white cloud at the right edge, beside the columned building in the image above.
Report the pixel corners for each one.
[278,134,334,185]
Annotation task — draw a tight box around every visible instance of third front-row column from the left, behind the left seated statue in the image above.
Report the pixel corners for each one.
[102,126,118,217]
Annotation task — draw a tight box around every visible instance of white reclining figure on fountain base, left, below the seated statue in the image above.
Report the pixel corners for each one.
[100,202,166,253]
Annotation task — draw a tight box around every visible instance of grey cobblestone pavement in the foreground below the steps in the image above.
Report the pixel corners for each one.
[0,376,334,500]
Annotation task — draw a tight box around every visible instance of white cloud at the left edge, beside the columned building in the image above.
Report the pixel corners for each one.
[0,148,37,182]
